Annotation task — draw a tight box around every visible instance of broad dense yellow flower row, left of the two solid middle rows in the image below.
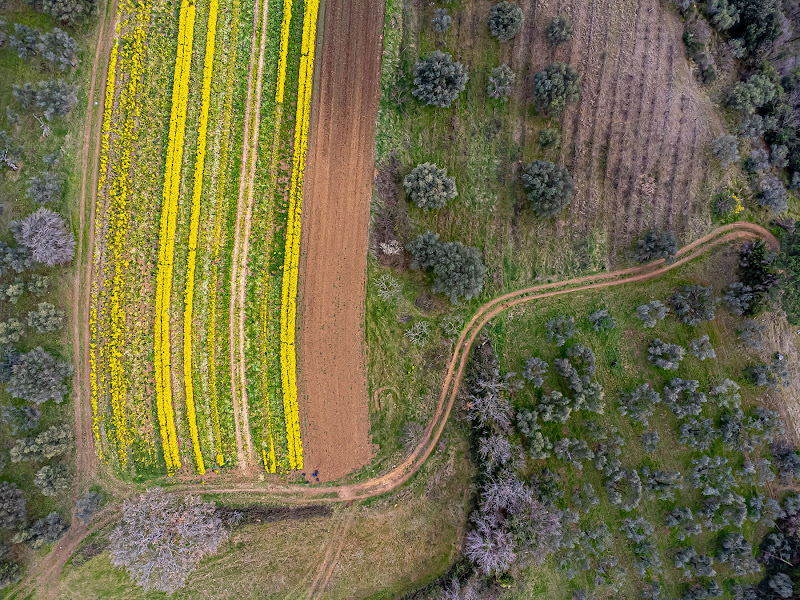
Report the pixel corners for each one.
[154,0,195,475]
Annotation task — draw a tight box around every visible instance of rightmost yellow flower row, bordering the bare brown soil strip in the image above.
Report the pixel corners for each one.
[281,0,319,470]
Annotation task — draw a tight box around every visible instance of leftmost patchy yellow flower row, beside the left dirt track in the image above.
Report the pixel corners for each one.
[89,39,119,460]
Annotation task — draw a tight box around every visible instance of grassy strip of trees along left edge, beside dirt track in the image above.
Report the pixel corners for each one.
[0,0,97,589]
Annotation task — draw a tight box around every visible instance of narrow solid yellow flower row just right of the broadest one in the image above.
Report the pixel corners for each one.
[183,0,219,475]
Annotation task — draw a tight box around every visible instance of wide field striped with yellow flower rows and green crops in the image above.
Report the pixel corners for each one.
[87,0,319,478]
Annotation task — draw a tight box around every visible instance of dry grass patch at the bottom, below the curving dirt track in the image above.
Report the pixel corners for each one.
[59,424,472,600]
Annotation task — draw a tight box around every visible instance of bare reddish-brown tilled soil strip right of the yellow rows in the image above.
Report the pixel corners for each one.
[298,0,384,481]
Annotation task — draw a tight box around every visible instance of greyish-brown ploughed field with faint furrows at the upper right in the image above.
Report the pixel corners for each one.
[510,0,721,264]
